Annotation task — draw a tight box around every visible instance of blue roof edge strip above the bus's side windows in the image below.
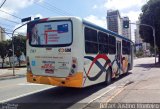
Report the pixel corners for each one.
[82,19,133,43]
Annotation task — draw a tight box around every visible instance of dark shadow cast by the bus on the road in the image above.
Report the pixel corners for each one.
[7,72,132,109]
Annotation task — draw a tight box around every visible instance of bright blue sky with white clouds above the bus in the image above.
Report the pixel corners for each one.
[0,0,148,40]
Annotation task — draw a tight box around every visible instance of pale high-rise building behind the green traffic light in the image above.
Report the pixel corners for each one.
[121,17,131,39]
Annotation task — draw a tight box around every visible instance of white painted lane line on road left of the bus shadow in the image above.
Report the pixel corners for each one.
[0,86,53,103]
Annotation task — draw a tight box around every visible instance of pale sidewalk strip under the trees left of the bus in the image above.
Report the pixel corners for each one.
[0,68,26,80]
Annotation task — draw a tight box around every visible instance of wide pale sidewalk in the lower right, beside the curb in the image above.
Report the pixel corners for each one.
[110,64,160,103]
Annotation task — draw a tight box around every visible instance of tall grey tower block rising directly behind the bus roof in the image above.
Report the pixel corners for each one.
[107,10,122,35]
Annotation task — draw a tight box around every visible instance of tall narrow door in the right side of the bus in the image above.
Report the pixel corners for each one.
[116,41,122,73]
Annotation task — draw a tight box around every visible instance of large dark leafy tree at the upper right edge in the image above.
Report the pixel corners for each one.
[139,0,160,63]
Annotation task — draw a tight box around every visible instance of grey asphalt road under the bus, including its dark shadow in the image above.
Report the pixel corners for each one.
[0,58,158,109]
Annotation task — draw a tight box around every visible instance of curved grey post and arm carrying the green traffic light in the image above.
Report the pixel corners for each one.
[130,23,157,64]
